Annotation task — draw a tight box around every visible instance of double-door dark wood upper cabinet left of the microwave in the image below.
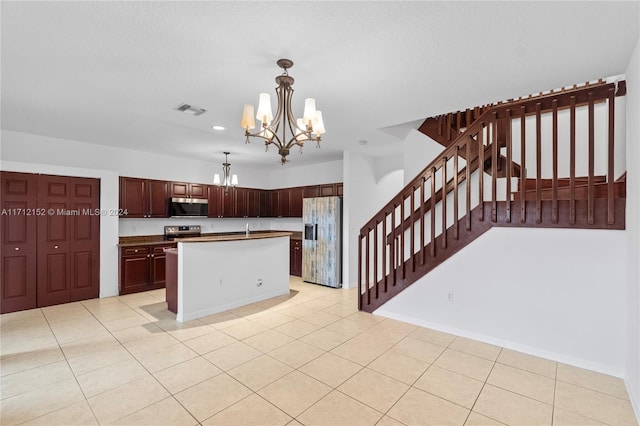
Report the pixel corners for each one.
[120,177,169,218]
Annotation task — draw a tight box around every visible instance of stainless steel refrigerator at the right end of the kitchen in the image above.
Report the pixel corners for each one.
[302,197,342,287]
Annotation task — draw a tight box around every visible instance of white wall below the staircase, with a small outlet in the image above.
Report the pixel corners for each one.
[375,228,627,376]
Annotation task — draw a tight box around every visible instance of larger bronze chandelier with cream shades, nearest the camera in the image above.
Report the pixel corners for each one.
[240,59,325,164]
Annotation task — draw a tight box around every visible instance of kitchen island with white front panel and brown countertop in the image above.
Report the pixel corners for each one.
[166,232,291,322]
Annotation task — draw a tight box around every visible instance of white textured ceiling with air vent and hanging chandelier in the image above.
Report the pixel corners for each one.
[0,1,640,167]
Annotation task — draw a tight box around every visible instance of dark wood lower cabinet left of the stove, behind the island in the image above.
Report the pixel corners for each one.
[119,244,176,294]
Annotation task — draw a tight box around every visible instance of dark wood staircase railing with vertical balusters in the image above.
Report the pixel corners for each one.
[358,82,625,312]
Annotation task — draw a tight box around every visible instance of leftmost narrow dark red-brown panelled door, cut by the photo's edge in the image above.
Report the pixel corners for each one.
[0,172,38,313]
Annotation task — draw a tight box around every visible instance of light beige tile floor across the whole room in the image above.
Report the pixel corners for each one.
[0,277,637,426]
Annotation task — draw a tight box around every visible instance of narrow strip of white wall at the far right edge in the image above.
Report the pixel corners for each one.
[625,39,640,419]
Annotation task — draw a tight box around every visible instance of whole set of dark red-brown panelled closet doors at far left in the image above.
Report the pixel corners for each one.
[1,172,100,313]
